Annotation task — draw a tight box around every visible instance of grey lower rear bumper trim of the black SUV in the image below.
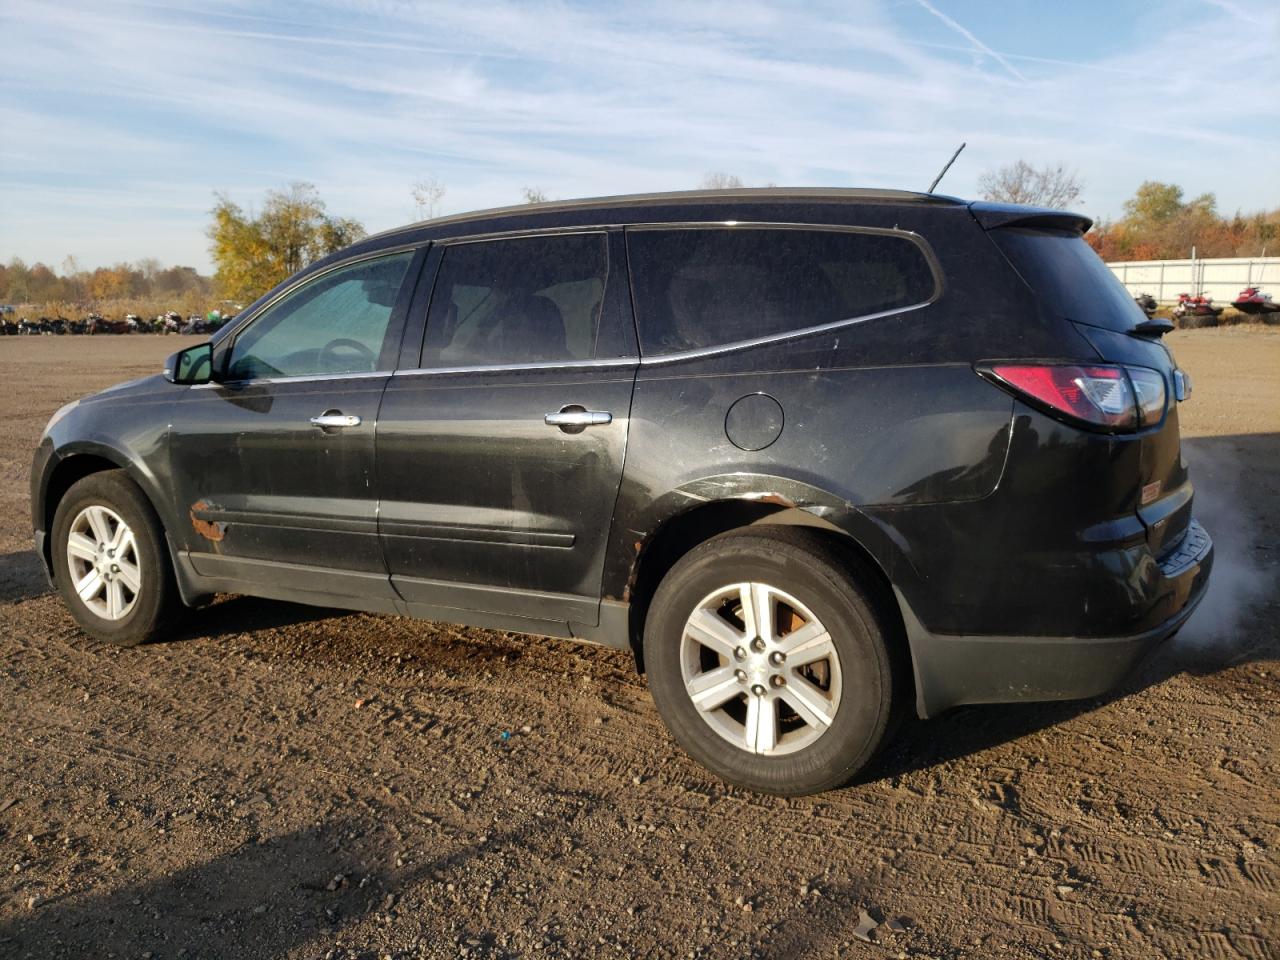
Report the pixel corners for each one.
[897,520,1213,717]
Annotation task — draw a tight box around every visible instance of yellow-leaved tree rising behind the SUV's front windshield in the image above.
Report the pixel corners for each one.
[209,183,365,301]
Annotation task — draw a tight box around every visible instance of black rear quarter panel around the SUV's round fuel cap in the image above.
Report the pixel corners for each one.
[604,206,1096,627]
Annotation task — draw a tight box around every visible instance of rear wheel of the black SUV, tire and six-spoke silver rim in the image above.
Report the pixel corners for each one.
[644,526,901,796]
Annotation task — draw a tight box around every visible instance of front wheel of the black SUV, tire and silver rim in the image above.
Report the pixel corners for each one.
[52,470,182,646]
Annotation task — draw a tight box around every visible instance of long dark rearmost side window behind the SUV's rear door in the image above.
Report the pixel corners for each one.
[627,227,937,356]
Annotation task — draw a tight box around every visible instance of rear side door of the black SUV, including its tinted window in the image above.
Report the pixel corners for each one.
[376,230,637,630]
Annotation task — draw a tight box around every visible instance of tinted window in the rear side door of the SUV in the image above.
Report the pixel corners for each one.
[422,233,608,367]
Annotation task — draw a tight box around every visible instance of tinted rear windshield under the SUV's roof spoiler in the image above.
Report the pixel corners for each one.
[991,227,1147,333]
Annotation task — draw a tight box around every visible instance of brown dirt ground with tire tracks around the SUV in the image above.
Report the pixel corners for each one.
[0,326,1280,960]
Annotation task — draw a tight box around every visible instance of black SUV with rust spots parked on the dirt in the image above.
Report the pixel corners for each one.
[32,189,1212,794]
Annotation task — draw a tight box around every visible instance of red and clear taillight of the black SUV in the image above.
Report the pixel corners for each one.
[978,364,1165,431]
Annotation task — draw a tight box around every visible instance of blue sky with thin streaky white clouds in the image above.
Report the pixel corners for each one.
[0,0,1280,271]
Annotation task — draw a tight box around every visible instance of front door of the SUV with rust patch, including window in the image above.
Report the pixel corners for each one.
[170,251,421,605]
